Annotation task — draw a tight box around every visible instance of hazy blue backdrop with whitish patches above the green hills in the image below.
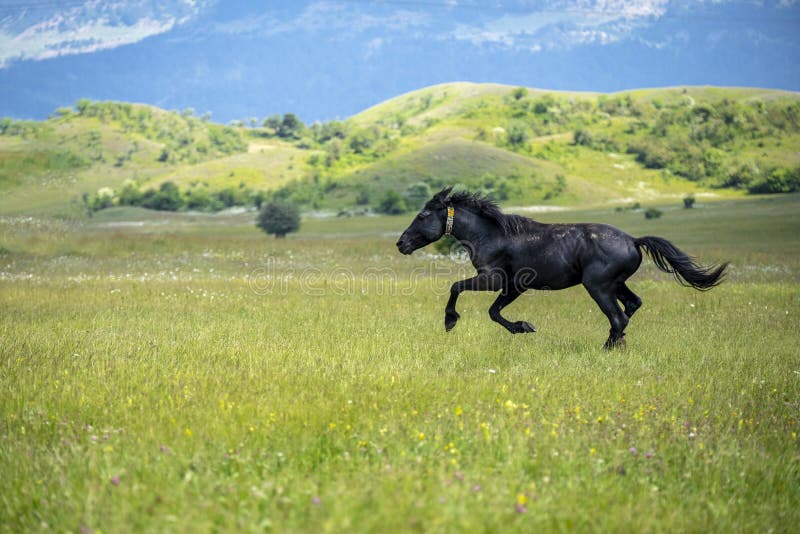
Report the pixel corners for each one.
[0,0,800,123]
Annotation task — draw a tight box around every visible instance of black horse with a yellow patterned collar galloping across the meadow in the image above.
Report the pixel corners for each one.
[397,187,728,349]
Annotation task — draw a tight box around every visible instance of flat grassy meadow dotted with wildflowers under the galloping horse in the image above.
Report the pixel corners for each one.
[0,195,800,532]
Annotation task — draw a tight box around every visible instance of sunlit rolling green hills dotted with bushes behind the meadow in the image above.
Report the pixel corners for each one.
[0,83,800,215]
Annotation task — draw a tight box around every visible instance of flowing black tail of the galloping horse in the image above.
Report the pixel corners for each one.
[633,236,728,291]
